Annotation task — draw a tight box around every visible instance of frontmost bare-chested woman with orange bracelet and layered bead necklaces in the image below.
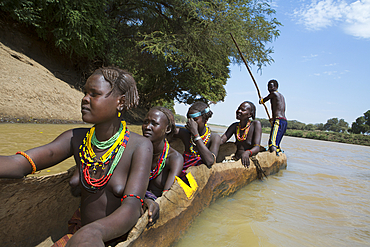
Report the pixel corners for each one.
[0,68,153,246]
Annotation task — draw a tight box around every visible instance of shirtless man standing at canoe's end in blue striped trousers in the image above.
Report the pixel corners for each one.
[259,80,287,153]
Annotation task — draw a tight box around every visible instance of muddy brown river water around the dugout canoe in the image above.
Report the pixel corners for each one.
[0,124,370,247]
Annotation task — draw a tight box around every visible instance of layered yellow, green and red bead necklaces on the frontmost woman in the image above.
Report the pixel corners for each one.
[79,121,130,192]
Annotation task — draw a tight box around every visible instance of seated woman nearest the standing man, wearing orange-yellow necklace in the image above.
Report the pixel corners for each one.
[221,101,262,167]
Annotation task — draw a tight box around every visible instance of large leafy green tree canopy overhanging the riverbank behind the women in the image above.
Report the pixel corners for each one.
[0,0,281,108]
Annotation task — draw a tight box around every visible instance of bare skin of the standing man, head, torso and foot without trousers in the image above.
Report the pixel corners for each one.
[259,80,286,152]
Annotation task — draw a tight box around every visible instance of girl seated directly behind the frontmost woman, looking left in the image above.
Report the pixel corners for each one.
[142,106,184,197]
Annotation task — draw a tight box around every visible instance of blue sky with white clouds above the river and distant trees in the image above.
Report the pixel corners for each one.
[175,0,370,126]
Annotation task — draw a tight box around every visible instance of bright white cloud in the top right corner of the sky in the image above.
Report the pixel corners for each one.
[294,0,370,38]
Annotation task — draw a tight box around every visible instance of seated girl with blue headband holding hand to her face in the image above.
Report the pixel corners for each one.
[174,101,221,179]
